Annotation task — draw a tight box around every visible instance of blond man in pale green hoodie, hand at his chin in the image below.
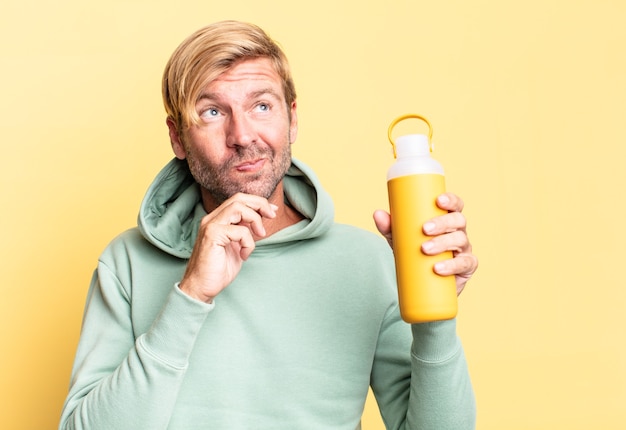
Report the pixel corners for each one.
[59,21,477,430]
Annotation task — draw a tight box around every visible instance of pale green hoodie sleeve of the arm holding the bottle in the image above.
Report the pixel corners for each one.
[371,309,476,430]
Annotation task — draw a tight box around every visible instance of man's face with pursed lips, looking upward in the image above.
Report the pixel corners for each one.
[168,58,297,210]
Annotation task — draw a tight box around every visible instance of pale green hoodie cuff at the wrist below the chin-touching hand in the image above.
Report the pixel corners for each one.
[139,284,215,368]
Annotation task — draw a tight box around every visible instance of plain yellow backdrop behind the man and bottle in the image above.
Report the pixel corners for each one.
[0,0,626,430]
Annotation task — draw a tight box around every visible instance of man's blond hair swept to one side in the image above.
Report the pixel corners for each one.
[162,21,296,130]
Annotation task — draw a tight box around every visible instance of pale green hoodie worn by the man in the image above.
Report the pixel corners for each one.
[59,159,475,430]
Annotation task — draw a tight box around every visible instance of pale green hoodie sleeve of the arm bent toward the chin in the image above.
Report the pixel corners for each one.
[59,262,212,430]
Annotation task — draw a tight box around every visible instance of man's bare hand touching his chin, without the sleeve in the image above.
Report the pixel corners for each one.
[179,193,278,303]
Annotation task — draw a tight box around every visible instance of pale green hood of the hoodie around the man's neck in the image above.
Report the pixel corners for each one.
[137,158,334,258]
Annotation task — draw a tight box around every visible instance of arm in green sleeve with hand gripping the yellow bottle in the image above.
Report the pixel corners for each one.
[372,193,478,430]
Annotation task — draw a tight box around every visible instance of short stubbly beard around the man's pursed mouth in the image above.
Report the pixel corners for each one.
[187,144,291,204]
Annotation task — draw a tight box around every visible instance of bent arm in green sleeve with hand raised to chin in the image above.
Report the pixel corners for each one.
[59,194,275,430]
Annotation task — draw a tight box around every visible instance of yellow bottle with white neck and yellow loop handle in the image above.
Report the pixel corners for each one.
[387,114,457,323]
